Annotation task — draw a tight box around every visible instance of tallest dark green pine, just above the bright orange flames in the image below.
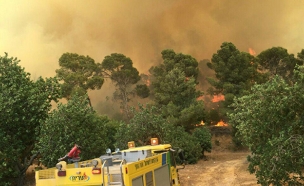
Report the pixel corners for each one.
[207,42,265,115]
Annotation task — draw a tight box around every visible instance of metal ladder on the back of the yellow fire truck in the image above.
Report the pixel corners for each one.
[102,159,127,186]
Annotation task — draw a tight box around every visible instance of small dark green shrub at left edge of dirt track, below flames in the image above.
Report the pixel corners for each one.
[193,127,212,157]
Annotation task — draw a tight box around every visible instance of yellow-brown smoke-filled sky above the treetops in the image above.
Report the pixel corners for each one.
[0,0,304,107]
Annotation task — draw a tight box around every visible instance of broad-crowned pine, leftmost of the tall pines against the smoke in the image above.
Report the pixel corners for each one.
[56,53,104,106]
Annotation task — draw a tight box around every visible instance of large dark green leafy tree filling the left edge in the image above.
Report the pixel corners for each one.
[0,54,60,185]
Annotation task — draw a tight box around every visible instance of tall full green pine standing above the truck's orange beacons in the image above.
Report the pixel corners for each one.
[150,50,205,131]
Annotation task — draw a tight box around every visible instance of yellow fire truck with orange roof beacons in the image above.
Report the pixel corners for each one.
[35,138,184,186]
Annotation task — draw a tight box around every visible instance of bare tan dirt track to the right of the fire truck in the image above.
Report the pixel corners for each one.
[25,135,259,186]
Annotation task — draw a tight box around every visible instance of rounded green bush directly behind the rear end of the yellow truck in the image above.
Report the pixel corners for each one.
[36,95,109,167]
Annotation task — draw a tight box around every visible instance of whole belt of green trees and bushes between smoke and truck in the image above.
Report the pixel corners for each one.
[0,42,304,185]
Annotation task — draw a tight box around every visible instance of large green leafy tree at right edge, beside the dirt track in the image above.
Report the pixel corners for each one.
[230,67,304,185]
